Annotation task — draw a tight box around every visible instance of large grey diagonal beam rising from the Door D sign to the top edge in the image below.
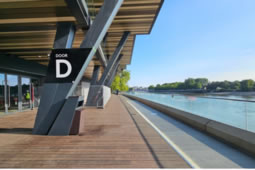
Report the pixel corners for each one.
[66,0,124,98]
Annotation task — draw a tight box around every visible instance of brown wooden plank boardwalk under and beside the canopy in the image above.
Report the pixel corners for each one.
[0,96,188,168]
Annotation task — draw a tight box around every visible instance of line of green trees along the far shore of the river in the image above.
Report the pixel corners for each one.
[149,78,255,91]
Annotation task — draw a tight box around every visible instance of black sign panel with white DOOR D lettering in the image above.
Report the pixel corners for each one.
[45,48,91,83]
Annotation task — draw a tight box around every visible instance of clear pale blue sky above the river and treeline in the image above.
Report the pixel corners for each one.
[127,0,255,87]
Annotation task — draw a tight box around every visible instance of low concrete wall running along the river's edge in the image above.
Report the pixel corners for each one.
[124,94,255,156]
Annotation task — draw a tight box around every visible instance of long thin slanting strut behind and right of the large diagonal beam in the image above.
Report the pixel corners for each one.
[98,32,130,85]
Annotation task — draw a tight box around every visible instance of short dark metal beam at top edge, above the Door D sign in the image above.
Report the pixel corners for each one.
[65,0,90,29]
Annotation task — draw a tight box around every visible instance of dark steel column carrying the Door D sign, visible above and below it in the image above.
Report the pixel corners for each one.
[33,23,76,135]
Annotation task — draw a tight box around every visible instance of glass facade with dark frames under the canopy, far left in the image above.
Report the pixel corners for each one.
[0,73,40,116]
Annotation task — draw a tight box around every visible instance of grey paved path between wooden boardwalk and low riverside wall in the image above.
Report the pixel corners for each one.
[124,99,255,168]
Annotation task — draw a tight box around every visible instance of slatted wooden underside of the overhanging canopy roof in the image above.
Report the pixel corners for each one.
[0,0,163,78]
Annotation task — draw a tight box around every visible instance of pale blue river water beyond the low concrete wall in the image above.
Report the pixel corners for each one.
[128,92,255,132]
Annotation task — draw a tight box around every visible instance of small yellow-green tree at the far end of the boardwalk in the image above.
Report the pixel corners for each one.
[111,70,130,91]
